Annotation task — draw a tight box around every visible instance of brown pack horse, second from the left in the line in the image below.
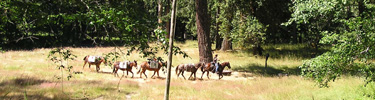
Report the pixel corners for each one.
[113,60,138,78]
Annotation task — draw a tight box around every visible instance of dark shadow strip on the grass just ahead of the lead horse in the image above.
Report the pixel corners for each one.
[232,64,301,76]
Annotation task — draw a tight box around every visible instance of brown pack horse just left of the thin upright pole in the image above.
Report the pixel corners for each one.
[137,61,167,78]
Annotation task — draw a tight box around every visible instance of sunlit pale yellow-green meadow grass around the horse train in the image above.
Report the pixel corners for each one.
[0,41,375,100]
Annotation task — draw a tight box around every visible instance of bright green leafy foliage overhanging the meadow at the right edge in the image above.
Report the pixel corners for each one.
[292,0,375,87]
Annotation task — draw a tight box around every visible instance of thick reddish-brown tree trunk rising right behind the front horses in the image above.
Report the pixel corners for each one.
[195,0,212,63]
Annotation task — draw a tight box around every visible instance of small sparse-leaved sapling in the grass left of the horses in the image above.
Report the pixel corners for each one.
[48,48,77,80]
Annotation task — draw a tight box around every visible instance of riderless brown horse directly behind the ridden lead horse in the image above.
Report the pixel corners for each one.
[176,63,204,80]
